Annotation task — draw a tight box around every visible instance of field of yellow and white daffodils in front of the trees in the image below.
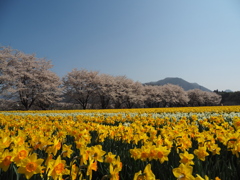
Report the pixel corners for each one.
[0,106,240,180]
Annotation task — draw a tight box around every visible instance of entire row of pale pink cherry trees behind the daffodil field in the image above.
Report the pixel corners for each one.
[0,47,221,110]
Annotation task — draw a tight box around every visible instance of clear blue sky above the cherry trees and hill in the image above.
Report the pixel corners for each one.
[0,0,240,91]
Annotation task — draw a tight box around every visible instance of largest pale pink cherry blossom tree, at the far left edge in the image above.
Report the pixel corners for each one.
[0,47,61,110]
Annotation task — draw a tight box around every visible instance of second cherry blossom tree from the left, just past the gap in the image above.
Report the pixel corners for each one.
[63,69,98,109]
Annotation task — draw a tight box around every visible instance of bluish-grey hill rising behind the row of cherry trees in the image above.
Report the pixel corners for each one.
[144,77,212,92]
